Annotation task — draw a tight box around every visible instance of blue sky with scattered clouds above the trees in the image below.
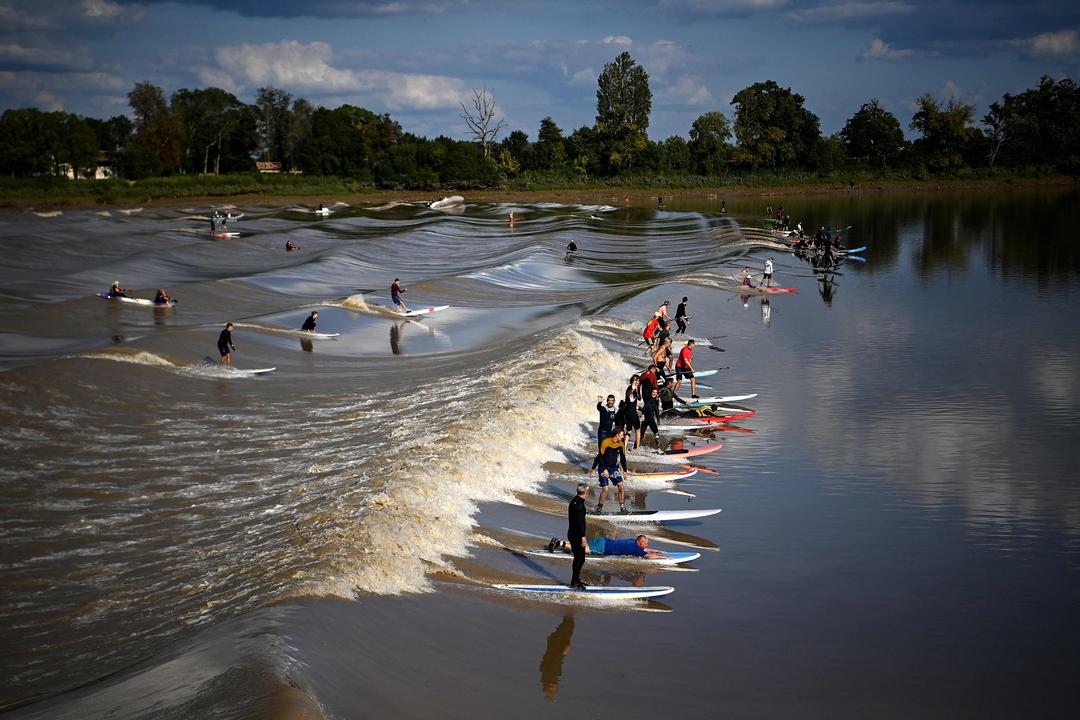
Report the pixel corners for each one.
[0,0,1080,141]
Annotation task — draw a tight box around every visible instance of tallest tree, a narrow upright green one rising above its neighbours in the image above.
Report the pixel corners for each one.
[596,53,652,171]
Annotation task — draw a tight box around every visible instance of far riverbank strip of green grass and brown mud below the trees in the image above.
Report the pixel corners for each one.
[0,172,1077,208]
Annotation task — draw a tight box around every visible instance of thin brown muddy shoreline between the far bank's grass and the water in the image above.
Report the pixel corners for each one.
[0,176,1080,212]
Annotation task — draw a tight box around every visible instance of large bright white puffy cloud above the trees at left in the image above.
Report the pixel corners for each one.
[208,40,464,109]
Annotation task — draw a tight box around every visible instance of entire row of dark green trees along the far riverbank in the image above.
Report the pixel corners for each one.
[0,53,1080,189]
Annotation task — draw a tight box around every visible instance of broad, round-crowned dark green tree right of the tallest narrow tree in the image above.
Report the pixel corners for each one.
[731,80,821,167]
